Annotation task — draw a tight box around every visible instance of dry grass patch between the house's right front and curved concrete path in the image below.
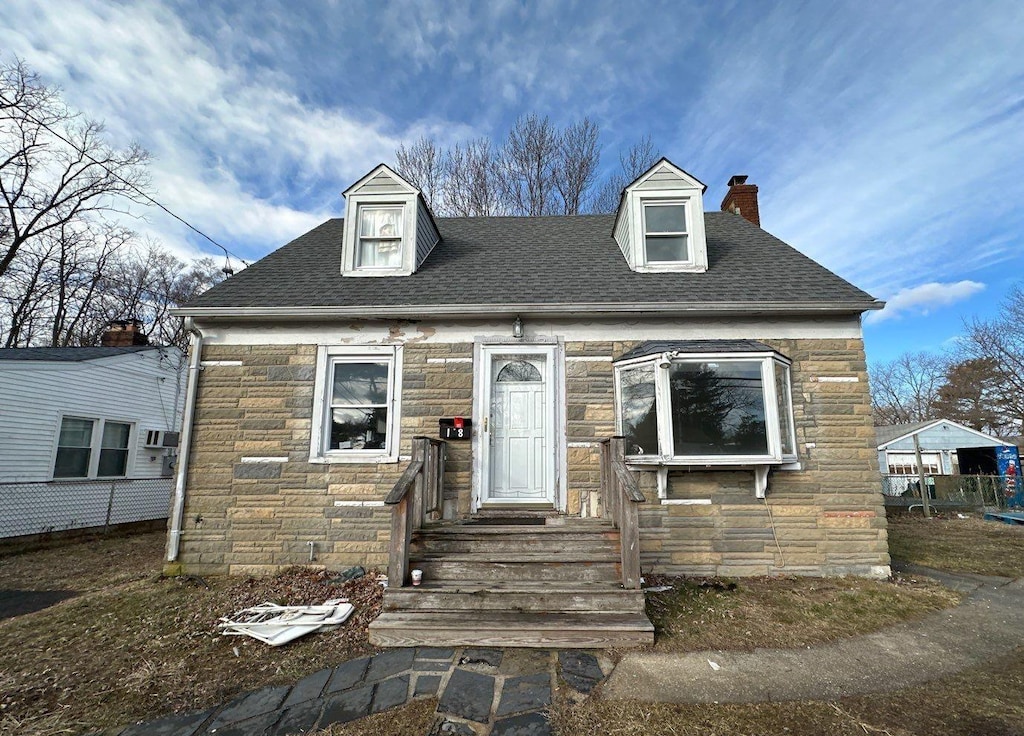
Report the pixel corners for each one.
[647,575,961,652]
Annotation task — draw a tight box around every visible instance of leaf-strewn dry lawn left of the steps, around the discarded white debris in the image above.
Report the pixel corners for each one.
[0,532,380,736]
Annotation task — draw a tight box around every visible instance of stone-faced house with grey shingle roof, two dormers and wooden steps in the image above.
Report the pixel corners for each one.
[166,159,889,646]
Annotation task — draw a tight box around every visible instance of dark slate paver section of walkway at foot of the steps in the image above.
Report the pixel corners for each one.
[105,647,611,736]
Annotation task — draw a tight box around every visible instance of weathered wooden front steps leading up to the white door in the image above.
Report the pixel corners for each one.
[370,516,654,648]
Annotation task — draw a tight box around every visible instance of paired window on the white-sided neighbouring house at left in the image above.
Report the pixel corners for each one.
[53,417,132,478]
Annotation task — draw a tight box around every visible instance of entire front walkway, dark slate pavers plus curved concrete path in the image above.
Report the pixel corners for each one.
[96,566,1024,736]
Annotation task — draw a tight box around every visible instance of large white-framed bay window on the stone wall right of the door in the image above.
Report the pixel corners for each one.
[615,351,796,465]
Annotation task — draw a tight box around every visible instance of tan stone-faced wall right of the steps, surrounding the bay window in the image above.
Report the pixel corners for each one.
[640,340,889,576]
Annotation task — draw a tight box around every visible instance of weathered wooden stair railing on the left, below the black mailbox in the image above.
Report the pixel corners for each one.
[384,437,445,588]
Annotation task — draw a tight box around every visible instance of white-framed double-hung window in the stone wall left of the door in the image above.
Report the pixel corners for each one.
[309,346,401,463]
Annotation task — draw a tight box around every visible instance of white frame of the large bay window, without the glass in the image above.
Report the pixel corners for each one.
[614,351,798,466]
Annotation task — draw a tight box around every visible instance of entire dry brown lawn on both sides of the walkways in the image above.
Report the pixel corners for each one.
[0,519,1024,736]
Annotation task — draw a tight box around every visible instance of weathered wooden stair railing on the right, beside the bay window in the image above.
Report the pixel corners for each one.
[601,437,647,591]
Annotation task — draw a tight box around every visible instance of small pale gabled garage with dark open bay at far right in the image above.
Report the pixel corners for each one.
[874,419,1020,495]
